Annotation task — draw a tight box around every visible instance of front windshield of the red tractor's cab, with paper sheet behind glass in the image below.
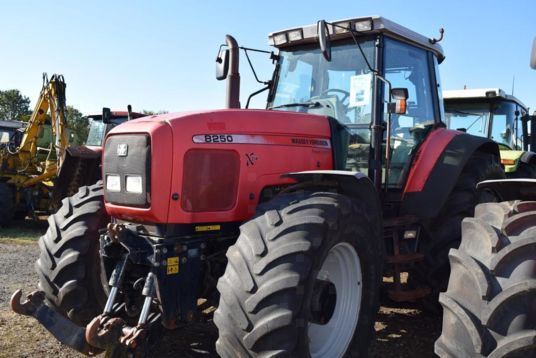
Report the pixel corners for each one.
[268,39,374,125]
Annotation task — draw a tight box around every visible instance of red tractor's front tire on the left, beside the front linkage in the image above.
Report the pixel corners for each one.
[35,182,109,326]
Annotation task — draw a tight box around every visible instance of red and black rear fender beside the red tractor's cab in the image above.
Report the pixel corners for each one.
[401,128,500,219]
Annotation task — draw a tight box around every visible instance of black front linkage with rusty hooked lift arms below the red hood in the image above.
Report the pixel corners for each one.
[11,224,211,356]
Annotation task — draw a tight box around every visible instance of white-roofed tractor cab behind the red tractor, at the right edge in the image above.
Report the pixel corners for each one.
[443,88,536,178]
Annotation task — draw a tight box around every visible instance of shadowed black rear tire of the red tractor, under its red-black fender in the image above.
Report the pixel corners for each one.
[410,153,505,300]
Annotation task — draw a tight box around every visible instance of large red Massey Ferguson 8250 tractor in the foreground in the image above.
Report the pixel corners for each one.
[11,17,504,357]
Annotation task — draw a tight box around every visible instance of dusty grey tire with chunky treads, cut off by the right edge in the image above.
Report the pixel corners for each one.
[435,202,536,357]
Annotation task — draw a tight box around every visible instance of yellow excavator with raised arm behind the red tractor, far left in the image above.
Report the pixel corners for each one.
[0,73,69,226]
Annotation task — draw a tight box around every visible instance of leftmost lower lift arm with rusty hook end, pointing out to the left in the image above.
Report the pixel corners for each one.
[10,290,102,356]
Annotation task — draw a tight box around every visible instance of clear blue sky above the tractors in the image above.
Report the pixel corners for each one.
[0,0,536,114]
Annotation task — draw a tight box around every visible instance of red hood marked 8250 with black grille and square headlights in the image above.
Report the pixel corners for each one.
[103,109,333,223]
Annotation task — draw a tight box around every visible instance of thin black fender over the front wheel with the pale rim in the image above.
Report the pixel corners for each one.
[283,170,382,238]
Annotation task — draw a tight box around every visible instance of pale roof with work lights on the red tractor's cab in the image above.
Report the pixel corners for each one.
[268,16,445,62]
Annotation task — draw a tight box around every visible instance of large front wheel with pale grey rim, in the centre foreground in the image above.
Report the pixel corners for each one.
[214,193,384,357]
